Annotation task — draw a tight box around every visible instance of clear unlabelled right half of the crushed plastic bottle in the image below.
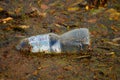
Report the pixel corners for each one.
[60,28,90,53]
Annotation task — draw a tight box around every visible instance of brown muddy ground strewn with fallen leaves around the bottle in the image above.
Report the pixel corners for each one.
[0,0,120,80]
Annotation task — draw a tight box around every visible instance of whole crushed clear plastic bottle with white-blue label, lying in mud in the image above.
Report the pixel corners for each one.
[16,28,90,53]
